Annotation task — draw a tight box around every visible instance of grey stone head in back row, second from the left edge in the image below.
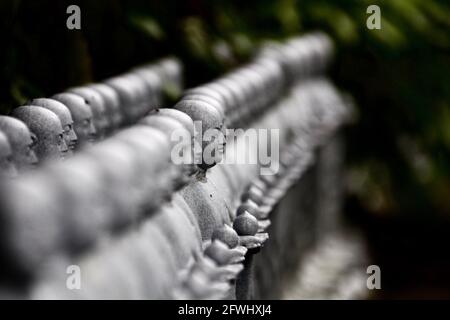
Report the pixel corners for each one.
[0,116,38,172]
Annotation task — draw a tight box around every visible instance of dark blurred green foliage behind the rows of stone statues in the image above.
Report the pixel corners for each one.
[0,0,450,218]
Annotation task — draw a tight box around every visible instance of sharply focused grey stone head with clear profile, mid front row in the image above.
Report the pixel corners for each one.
[174,100,226,170]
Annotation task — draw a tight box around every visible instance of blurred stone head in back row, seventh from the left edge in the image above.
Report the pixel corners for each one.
[89,83,123,133]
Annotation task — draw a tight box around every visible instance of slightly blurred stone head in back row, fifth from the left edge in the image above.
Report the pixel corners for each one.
[52,93,97,149]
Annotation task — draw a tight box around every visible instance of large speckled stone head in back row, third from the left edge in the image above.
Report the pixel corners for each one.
[11,106,69,161]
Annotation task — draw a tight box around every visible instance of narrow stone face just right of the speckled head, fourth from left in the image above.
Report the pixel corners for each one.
[29,98,78,154]
